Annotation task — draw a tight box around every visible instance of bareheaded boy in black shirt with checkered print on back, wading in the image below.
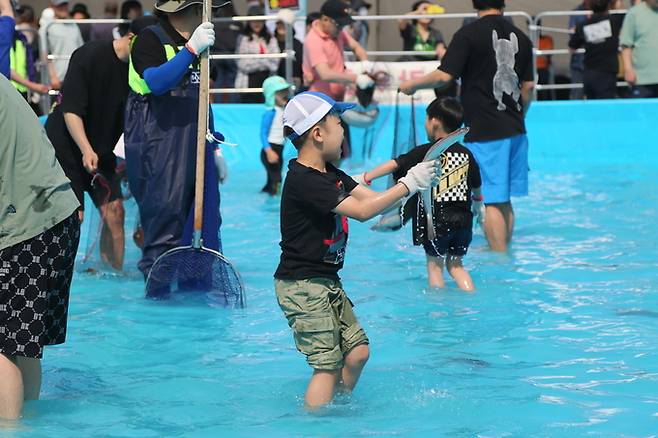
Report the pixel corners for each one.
[357,97,484,291]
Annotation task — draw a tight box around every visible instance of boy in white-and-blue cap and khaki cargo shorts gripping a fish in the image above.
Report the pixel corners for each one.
[274,92,439,407]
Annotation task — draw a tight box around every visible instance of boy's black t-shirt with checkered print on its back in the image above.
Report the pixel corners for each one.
[393,143,482,245]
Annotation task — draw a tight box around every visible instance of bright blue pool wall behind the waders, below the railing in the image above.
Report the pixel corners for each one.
[213,99,658,172]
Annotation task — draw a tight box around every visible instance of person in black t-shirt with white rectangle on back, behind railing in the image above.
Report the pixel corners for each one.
[569,0,624,99]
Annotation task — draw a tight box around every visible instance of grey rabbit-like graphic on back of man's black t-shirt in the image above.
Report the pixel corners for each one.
[492,30,521,111]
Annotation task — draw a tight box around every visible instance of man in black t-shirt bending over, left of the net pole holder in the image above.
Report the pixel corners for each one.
[46,23,144,270]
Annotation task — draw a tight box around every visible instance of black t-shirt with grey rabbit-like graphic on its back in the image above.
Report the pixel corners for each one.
[439,15,533,142]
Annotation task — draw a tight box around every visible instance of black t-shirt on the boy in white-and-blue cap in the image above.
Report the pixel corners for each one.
[274,160,357,280]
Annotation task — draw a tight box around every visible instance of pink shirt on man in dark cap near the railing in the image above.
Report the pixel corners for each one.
[302,20,350,101]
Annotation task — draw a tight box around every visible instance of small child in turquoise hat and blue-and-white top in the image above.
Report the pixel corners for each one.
[260,76,291,196]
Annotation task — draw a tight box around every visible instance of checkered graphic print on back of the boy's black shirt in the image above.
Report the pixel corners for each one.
[432,152,469,202]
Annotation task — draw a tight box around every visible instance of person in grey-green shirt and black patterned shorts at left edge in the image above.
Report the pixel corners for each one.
[0,75,80,423]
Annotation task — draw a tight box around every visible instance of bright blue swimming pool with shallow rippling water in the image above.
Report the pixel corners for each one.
[5,102,658,437]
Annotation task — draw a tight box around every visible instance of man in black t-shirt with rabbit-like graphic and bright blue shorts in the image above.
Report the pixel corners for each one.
[400,0,534,252]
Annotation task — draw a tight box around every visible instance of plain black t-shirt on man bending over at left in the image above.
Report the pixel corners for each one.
[46,41,128,174]
